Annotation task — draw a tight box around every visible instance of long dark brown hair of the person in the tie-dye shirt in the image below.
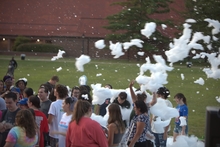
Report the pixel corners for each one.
[15,109,37,138]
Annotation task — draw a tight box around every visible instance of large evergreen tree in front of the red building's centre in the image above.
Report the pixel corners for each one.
[104,0,172,50]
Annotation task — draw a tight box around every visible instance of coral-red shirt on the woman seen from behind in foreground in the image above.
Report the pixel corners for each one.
[66,117,108,147]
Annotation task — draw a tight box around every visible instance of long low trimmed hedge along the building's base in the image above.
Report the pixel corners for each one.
[16,43,63,53]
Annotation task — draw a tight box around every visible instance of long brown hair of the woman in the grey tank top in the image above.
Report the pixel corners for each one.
[108,103,125,132]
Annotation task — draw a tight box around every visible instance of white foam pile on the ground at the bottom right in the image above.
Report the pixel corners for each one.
[167,135,205,147]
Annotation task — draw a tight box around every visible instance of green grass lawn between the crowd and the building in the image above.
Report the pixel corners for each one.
[0,56,220,139]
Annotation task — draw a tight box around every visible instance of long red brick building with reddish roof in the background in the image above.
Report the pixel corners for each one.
[0,0,184,58]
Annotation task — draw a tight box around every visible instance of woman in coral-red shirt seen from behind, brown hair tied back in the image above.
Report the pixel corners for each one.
[66,100,108,147]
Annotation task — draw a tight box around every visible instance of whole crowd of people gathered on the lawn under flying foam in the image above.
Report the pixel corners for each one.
[0,75,188,147]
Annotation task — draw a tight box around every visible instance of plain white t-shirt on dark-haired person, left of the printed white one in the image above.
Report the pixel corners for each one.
[48,99,64,139]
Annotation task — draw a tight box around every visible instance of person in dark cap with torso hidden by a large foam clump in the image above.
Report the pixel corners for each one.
[151,87,173,147]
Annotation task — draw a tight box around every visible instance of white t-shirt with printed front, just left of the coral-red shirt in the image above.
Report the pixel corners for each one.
[58,113,72,147]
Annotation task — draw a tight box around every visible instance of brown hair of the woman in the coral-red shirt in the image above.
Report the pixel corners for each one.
[71,100,92,124]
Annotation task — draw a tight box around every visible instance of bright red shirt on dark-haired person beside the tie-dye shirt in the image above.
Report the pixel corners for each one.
[34,110,49,147]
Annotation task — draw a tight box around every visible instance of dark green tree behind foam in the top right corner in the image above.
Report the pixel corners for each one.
[185,0,220,52]
